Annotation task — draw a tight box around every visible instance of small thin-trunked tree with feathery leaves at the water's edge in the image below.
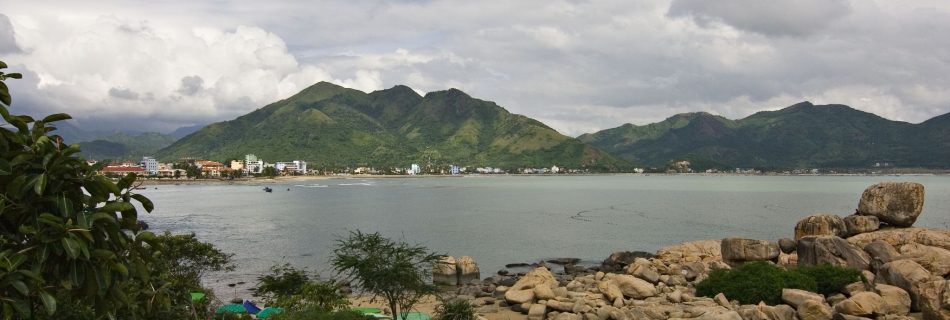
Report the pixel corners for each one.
[331,231,444,319]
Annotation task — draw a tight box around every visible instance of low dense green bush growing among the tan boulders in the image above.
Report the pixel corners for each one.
[696,261,817,305]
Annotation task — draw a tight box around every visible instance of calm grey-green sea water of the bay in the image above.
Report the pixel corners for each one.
[141,175,950,298]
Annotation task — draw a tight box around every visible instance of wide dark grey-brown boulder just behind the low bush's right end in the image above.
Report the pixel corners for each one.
[798,236,871,270]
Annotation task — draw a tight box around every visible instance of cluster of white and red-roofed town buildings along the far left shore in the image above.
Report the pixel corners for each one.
[91,154,308,178]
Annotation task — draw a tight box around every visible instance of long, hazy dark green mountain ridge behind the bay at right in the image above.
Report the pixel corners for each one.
[578,102,950,168]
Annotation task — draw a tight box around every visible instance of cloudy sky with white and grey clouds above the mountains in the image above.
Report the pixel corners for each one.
[0,0,950,136]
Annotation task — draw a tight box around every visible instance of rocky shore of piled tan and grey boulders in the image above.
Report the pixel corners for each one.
[434,182,950,320]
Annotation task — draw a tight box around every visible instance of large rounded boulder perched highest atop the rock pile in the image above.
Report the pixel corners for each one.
[858,182,924,228]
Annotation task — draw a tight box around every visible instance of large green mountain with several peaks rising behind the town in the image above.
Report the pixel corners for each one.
[158,82,622,169]
